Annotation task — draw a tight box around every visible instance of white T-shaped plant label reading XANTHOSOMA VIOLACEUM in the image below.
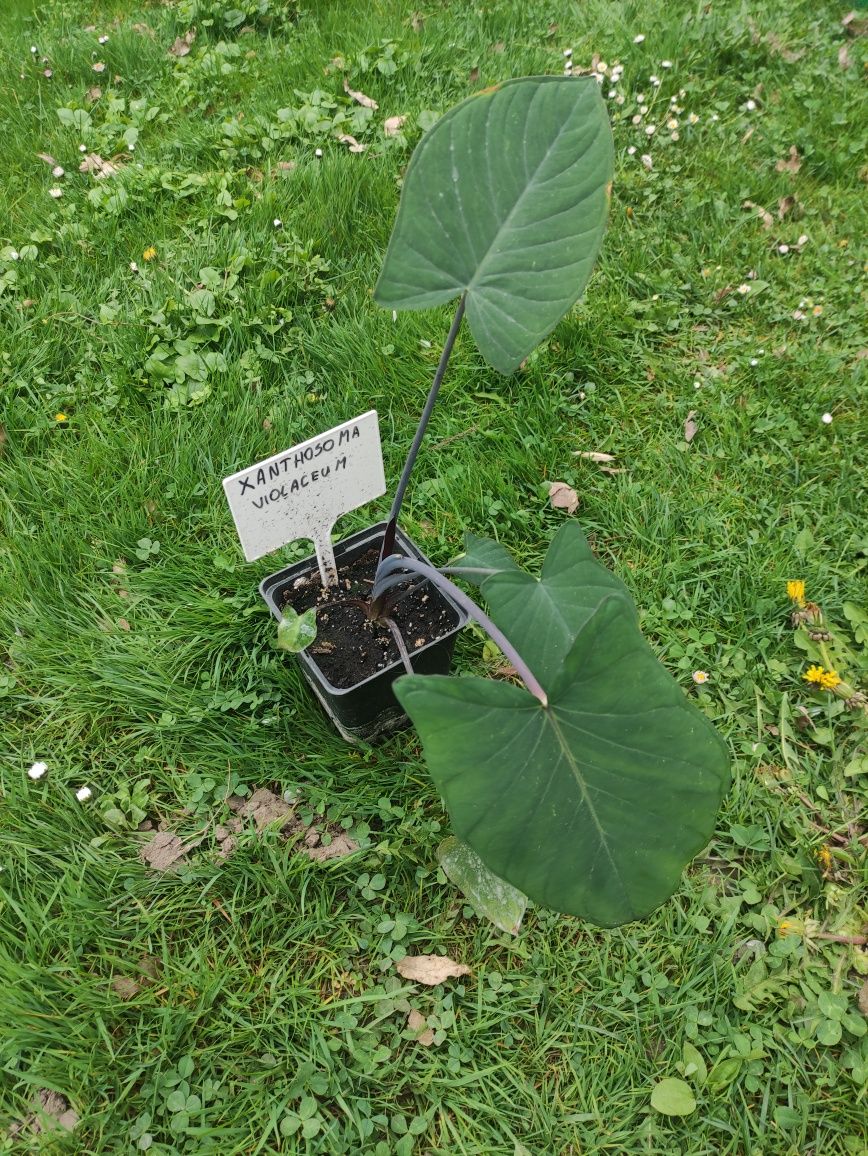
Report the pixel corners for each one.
[223,409,386,586]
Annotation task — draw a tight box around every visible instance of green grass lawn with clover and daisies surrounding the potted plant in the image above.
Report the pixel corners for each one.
[0,0,868,1156]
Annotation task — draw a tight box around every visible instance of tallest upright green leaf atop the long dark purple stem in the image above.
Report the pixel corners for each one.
[374,76,613,373]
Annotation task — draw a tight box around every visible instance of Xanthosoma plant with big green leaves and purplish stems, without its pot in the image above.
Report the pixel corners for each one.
[261,76,729,926]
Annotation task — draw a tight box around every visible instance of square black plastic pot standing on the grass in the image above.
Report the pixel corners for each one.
[259,521,467,742]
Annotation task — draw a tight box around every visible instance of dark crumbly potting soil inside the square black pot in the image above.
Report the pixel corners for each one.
[281,546,458,690]
